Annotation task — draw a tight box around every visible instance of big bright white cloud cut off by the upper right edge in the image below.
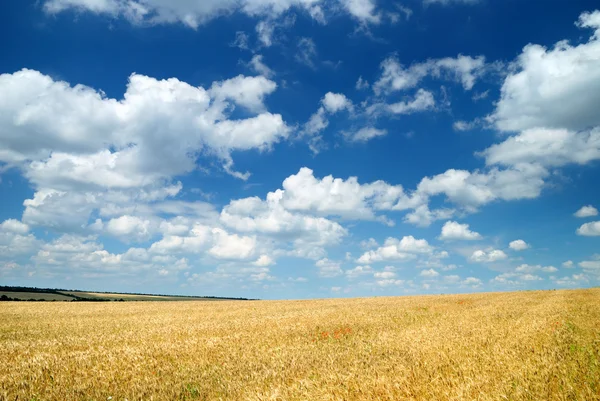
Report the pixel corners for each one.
[492,11,600,131]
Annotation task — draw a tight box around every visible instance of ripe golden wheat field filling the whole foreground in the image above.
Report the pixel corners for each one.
[0,289,600,401]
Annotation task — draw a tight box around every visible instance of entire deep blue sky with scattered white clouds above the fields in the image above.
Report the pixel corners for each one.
[0,0,600,299]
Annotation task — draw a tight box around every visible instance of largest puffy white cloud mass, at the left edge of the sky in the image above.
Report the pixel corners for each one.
[0,70,289,181]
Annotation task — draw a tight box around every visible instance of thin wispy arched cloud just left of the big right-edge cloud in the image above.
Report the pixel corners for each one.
[373,54,486,94]
